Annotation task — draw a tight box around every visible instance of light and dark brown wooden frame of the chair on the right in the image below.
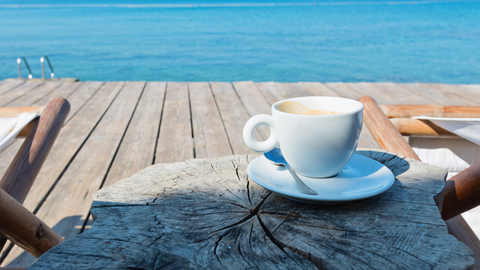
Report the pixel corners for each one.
[359,96,480,269]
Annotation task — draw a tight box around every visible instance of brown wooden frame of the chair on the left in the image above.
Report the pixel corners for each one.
[0,97,70,266]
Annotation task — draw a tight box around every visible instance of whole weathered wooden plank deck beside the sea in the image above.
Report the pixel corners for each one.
[0,80,480,266]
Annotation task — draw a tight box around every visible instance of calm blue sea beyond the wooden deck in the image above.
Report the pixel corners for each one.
[0,0,480,84]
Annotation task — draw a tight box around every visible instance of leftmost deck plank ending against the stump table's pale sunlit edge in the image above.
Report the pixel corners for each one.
[103,82,167,186]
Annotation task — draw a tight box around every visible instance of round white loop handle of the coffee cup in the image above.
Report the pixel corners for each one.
[243,114,278,153]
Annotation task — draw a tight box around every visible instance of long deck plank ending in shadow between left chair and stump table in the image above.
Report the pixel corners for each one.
[0,82,143,267]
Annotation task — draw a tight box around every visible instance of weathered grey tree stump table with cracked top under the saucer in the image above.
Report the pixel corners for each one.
[30,150,474,269]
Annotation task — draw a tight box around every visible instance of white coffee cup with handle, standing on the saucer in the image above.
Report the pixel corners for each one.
[243,97,363,178]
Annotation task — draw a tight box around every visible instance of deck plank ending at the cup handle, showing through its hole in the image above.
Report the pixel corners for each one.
[233,81,272,140]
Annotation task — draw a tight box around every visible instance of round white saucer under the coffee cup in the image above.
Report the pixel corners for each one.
[247,154,395,204]
